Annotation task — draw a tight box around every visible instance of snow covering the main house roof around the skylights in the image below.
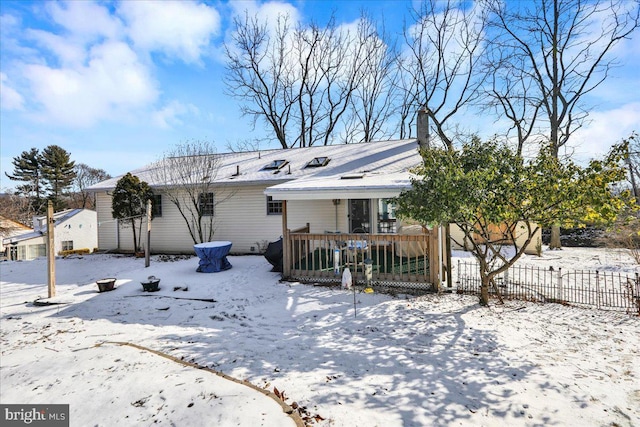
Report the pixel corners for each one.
[89,139,421,191]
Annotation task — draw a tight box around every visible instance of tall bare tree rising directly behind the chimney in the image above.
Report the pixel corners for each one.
[398,0,485,150]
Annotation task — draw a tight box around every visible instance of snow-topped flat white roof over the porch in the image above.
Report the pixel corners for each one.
[265,171,411,200]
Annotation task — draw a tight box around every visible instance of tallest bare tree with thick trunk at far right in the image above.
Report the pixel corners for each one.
[487,0,640,248]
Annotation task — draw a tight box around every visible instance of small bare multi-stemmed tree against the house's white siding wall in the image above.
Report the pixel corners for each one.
[151,140,232,244]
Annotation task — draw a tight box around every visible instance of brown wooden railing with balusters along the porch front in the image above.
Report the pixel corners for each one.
[283,231,440,284]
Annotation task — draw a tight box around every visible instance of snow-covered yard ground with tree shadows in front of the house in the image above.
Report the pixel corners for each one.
[0,249,640,427]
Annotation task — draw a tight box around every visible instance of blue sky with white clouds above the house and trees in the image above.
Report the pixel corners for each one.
[0,0,640,188]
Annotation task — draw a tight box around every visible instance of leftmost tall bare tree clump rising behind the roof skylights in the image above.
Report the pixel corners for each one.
[225,11,367,148]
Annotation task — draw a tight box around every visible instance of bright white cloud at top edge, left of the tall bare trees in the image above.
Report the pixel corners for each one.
[118,1,220,63]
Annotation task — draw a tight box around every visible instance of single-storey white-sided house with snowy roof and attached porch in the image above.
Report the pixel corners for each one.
[90,139,540,290]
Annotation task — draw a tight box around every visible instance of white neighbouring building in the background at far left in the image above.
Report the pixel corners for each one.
[2,209,98,260]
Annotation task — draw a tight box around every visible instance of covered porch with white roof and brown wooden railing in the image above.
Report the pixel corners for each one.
[265,174,446,290]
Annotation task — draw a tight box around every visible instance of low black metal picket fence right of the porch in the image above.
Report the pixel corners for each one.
[456,261,640,315]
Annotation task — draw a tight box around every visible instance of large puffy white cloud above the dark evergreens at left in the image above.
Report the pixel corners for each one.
[25,42,158,126]
